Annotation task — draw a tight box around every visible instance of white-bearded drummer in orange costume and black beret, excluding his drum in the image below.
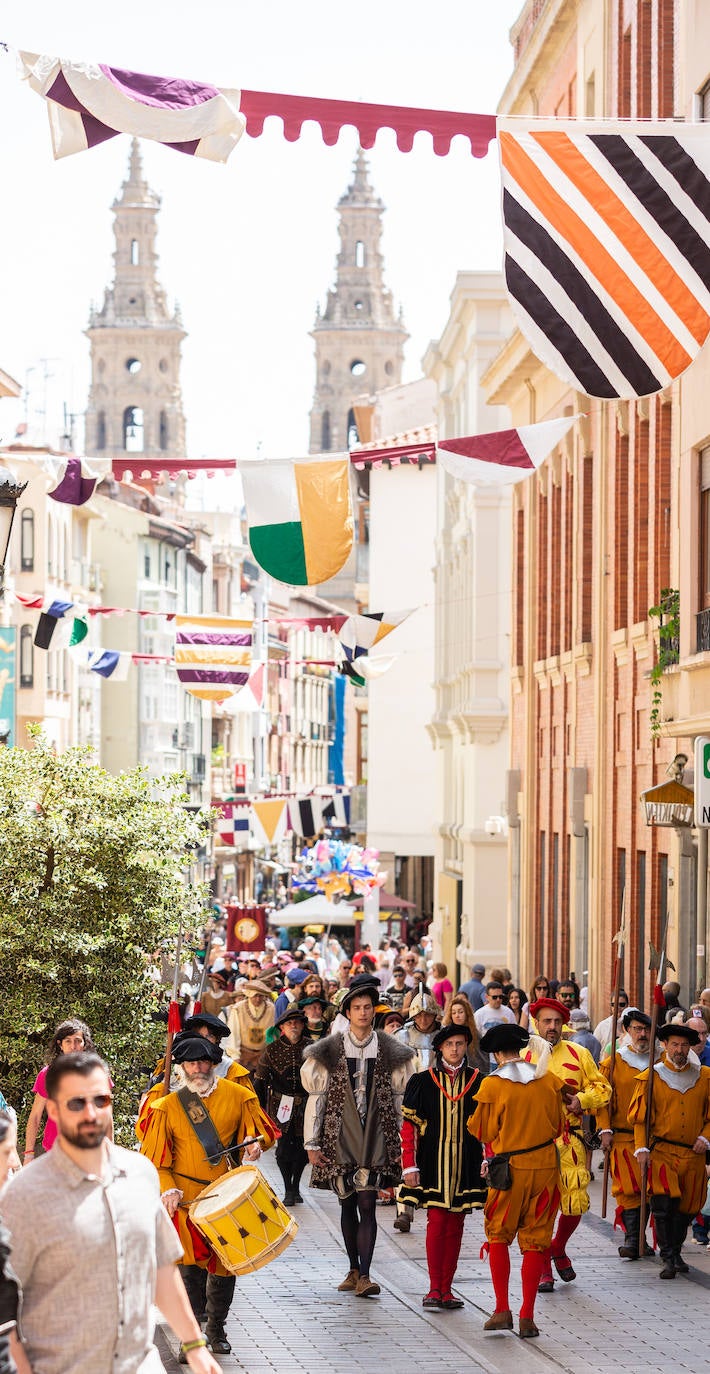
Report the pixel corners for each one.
[140,1036,273,1355]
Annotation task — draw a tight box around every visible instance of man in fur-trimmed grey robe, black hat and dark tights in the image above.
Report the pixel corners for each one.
[301,977,413,1297]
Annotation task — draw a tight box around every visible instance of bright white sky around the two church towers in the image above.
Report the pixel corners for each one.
[0,0,523,458]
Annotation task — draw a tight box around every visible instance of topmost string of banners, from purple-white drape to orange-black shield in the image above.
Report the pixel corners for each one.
[18,52,710,401]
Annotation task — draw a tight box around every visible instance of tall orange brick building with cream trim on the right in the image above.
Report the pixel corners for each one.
[483,0,694,1014]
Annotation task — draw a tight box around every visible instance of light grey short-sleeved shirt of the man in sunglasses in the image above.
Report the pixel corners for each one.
[1,1142,183,1374]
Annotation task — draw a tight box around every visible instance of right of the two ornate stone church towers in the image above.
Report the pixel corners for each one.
[310,148,408,453]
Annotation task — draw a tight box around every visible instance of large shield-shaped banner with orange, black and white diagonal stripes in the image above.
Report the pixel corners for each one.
[499,118,710,400]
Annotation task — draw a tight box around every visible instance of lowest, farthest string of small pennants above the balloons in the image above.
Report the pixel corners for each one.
[214,789,350,846]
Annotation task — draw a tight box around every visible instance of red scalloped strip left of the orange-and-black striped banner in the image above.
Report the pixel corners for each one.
[239,91,496,158]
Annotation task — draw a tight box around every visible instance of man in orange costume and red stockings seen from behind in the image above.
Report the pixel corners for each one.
[468,1025,564,1338]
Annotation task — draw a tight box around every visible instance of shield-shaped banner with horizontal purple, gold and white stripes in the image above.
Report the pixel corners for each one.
[174,616,254,701]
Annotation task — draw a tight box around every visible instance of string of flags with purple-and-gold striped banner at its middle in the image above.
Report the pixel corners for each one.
[15,592,412,703]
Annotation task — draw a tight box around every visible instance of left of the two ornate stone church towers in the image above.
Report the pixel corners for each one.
[85,139,185,458]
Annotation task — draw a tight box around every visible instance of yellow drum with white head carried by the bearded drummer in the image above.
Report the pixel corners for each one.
[190,1164,298,1274]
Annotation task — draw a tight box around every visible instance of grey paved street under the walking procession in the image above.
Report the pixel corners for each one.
[163,1157,710,1374]
